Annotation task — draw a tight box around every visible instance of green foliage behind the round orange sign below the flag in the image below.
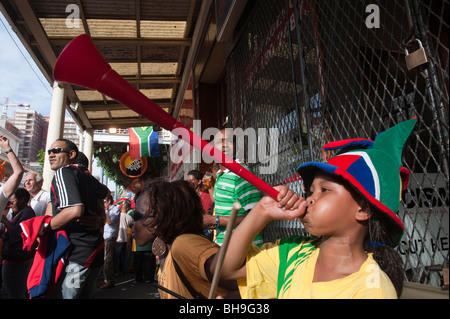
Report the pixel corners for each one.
[94,145,164,188]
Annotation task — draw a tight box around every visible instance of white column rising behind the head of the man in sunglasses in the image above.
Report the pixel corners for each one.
[42,82,66,192]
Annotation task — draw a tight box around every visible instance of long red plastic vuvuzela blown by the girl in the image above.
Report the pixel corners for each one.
[53,34,278,199]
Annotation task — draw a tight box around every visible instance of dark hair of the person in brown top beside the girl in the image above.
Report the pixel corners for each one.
[140,181,203,245]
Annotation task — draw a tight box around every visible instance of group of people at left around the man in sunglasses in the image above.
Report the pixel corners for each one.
[0,136,156,299]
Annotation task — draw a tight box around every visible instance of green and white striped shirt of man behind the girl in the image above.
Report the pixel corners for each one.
[214,164,263,246]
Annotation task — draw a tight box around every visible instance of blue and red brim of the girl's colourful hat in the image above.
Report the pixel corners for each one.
[297,162,405,247]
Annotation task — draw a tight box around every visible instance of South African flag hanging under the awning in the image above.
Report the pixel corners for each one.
[128,126,161,158]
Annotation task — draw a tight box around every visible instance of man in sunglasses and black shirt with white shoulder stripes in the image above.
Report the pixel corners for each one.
[47,139,108,299]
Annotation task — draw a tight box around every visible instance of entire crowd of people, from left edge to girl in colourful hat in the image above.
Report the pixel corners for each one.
[0,119,417,299]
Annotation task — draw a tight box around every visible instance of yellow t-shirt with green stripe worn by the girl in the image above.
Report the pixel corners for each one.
[238,236,397,299]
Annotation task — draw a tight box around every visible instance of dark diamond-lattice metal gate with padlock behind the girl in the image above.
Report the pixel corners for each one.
[227,0,449,286]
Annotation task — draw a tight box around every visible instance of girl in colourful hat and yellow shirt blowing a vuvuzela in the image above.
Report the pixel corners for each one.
[216,119,417,299]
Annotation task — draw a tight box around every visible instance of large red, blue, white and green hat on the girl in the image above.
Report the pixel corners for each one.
[297,118,417,247]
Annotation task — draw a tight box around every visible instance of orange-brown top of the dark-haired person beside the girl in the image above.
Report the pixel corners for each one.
[158,234,228,299]
